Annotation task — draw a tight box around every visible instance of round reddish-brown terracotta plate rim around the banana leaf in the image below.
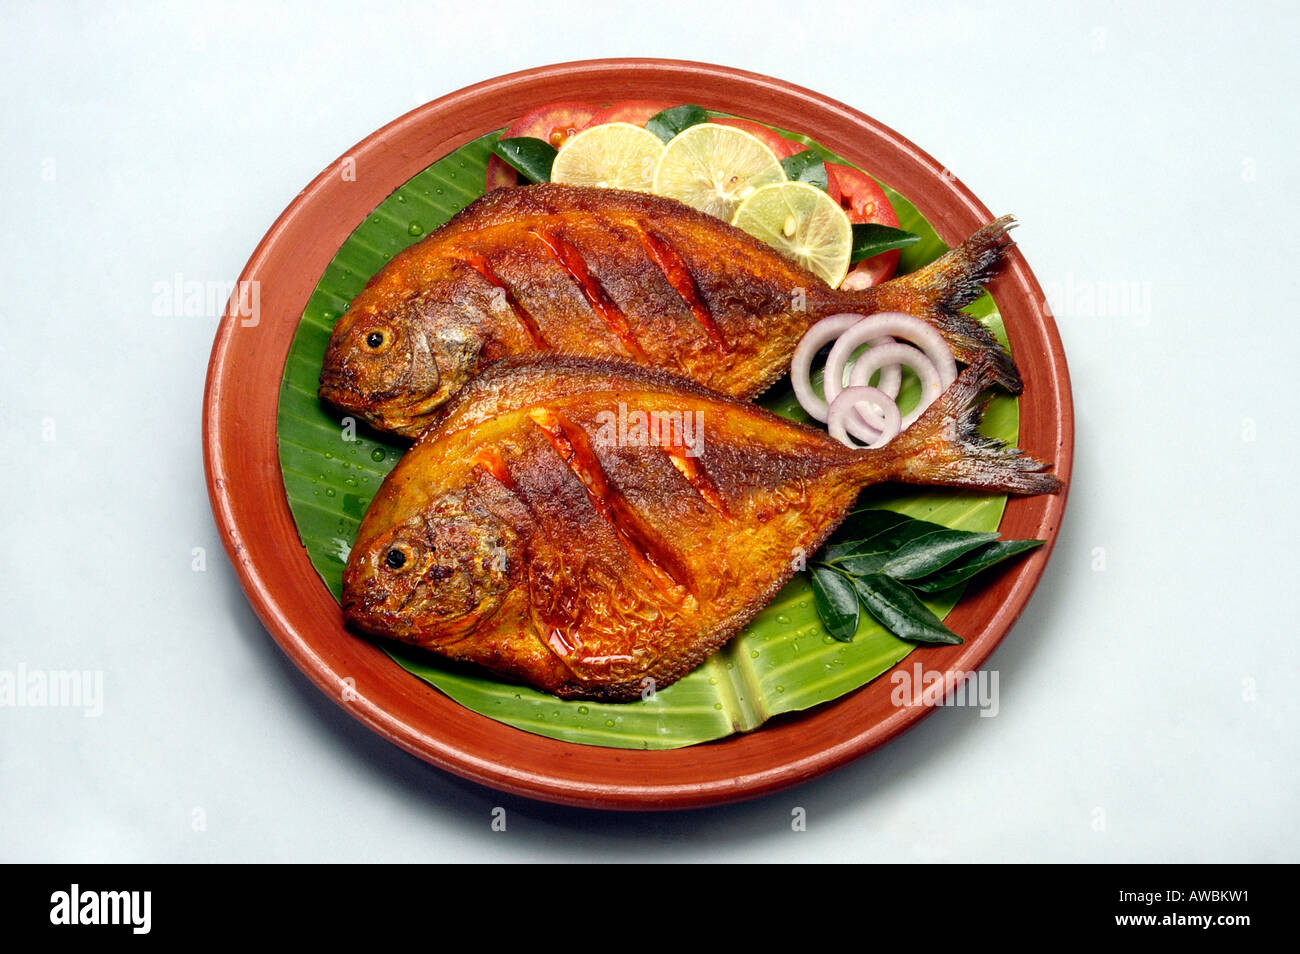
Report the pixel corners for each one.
[203,60,1074,808]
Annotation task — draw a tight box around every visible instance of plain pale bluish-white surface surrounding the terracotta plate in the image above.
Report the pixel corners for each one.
[0,1,1300,862]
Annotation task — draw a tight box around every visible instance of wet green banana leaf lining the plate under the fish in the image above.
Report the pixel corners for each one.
[277,123,1018,749]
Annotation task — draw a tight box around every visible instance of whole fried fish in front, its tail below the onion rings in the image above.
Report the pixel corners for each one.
[343,356,1058,701]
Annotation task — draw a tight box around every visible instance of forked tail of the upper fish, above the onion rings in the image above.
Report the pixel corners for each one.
[861,216,1024,394]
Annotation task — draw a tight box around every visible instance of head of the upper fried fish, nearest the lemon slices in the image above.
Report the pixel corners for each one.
[320,298,482,438]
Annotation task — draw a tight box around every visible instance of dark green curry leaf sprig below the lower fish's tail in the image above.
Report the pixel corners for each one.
[809,509,1043,643]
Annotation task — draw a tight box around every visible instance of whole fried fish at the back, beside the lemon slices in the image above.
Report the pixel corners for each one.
[320,183,1019,437]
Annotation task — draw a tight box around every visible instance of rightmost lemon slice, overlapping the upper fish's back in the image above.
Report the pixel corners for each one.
[732,182,853,289]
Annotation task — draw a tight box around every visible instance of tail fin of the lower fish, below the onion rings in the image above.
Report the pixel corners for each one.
[863,354,1061,494]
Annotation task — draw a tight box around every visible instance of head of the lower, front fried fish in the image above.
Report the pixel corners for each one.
[343,491,520,647]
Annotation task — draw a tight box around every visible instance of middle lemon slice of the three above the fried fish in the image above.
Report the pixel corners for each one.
[654,122,785,222]
